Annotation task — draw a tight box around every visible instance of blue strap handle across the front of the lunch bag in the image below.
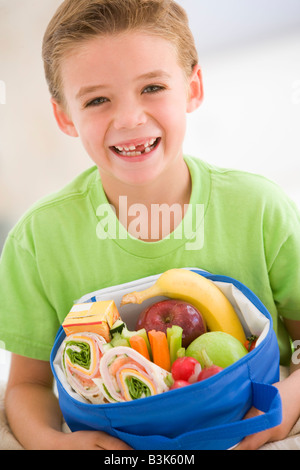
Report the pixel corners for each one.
[115,382,282,450]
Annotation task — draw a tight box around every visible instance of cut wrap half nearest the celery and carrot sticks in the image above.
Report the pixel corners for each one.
[93,346,170,403]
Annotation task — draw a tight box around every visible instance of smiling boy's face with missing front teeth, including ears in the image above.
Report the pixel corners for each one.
[53,32,202,188]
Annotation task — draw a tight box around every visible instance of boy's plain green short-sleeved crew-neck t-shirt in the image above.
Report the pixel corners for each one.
[0,157,300,360]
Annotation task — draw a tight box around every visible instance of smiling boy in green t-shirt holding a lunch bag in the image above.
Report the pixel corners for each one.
[0,0,300,450]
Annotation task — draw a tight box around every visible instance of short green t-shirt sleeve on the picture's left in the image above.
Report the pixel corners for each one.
[0,235,59,361]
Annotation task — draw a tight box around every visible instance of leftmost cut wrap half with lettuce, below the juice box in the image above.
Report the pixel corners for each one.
[62,333,107,404]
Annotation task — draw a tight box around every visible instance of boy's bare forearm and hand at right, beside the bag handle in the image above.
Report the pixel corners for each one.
[235,370,300,450]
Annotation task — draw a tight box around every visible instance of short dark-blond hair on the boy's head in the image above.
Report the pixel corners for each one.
[42,0,198,102]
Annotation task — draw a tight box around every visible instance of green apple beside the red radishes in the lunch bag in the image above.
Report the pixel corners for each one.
[185,331,248,369]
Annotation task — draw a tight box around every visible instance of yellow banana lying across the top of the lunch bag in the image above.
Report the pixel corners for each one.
[121,269,246,343]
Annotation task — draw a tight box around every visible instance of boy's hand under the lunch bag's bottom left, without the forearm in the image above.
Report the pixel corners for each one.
[56,431,132,450]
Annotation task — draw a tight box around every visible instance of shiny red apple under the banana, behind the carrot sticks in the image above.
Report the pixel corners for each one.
[135,299,206,348]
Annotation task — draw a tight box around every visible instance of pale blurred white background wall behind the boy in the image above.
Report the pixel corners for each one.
[0,0,300,379]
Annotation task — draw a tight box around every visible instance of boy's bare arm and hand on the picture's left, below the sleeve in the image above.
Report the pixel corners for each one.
[5,354,130,450]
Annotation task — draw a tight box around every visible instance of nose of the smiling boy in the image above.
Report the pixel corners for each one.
[114,100,147,130]
